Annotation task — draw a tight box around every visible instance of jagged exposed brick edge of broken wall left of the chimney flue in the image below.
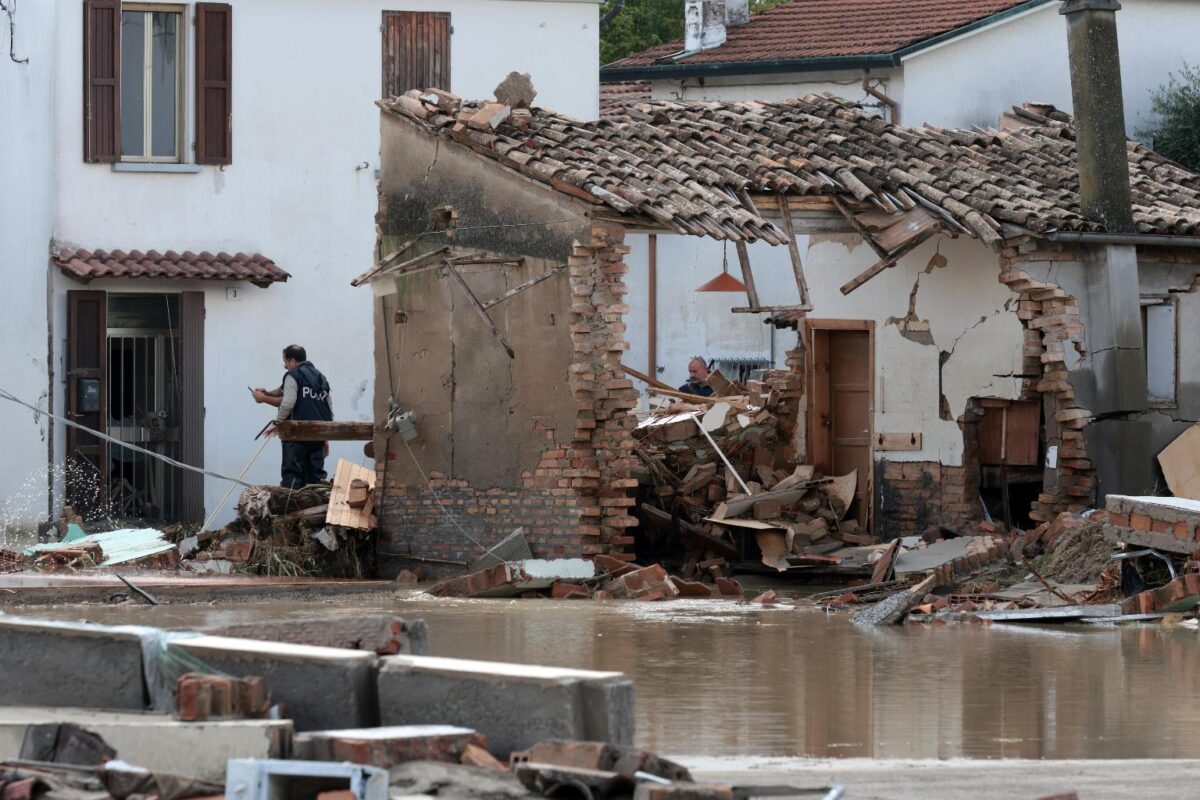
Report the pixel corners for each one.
[1000,236,1096,522]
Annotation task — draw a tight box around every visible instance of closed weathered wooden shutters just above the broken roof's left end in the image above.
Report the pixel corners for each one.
[383,11,450,97]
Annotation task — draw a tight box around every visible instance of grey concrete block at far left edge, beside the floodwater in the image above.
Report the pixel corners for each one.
[0,614,152,711]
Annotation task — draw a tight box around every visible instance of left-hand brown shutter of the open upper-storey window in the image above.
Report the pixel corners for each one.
[83,0,121,163]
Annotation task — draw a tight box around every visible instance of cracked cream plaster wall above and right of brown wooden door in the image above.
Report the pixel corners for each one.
[802,234,1024,467]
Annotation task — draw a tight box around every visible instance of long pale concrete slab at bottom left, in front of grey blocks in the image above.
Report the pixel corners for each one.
[0,706,292,782]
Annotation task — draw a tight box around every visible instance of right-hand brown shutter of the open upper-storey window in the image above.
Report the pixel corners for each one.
[196,2,233,164]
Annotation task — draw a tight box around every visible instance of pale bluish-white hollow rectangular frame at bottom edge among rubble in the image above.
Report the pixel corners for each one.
[224,758,388,800]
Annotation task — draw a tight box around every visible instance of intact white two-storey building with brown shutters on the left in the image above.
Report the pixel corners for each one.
[0,0,599,541]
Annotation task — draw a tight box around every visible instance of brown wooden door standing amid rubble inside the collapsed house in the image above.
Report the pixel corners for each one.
[809,325,874,528]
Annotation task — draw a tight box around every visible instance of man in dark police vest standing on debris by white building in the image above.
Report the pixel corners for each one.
[252,344,334,489]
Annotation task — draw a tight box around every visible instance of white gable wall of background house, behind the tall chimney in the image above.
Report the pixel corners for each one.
[901,0,1200,136]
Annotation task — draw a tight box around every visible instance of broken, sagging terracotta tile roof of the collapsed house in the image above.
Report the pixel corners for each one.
[379,92,1200,246]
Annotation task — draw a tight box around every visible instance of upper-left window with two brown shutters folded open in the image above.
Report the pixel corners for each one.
[83,0,233,164]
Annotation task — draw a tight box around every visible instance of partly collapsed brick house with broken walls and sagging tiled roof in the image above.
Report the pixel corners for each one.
[359,2,1200,573]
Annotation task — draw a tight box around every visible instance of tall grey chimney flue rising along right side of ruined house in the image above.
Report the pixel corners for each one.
[1058,0,1154,497]
